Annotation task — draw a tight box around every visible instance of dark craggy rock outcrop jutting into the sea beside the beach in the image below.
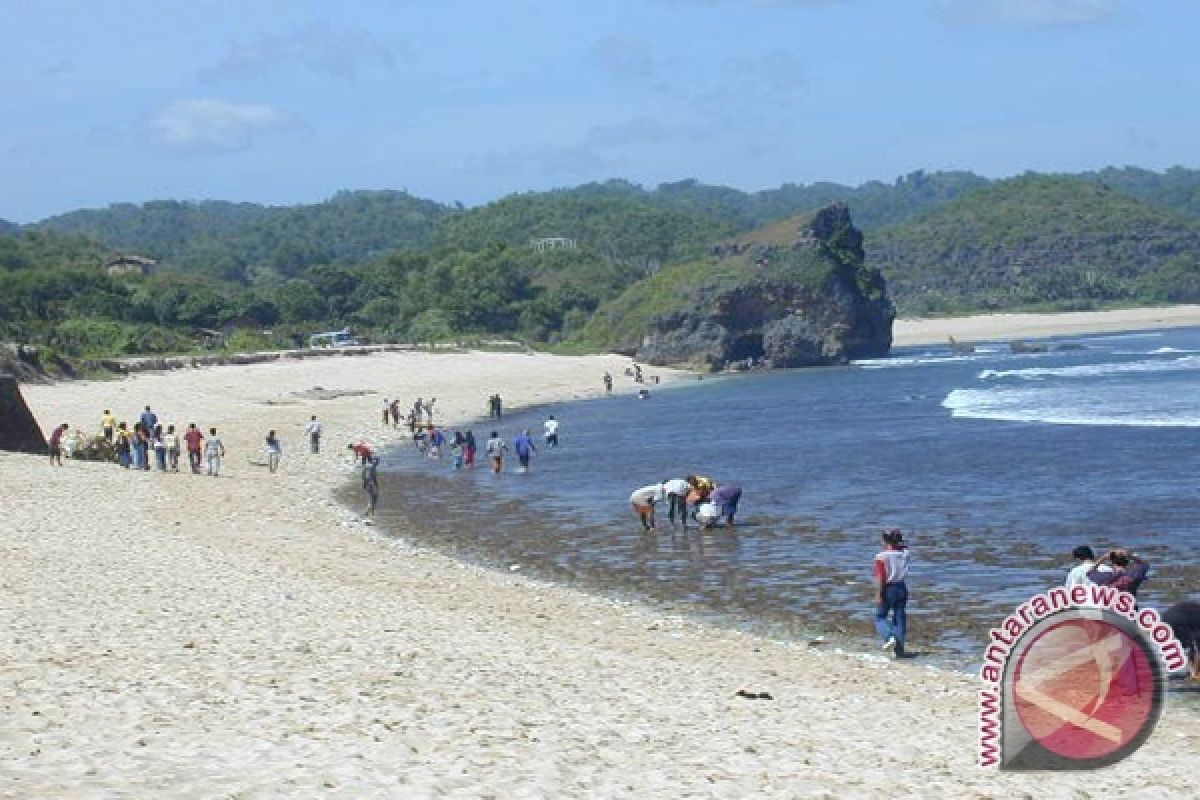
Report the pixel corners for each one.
[636,203,895,371]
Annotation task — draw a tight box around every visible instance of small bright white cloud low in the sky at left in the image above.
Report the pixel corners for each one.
[150,97,294,152]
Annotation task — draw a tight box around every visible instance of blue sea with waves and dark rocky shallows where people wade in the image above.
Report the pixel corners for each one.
[369,329,1200,681]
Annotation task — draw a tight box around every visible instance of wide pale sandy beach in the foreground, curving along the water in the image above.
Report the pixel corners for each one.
[0,352,1200,799]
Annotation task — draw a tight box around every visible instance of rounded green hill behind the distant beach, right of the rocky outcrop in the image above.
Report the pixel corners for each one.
[868,174,1200,313]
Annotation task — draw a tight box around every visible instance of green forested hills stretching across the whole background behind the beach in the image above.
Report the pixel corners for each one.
[7,168,1200,367]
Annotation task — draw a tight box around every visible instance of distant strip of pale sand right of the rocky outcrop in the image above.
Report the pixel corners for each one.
[892,306,1200,347]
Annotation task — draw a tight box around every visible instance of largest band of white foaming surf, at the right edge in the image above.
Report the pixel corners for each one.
[942,387,1200,428]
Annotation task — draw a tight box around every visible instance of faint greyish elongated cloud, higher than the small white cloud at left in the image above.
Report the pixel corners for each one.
[200,23,407,80]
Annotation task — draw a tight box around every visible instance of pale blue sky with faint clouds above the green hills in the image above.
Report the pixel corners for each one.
[0,0,1200,223]
